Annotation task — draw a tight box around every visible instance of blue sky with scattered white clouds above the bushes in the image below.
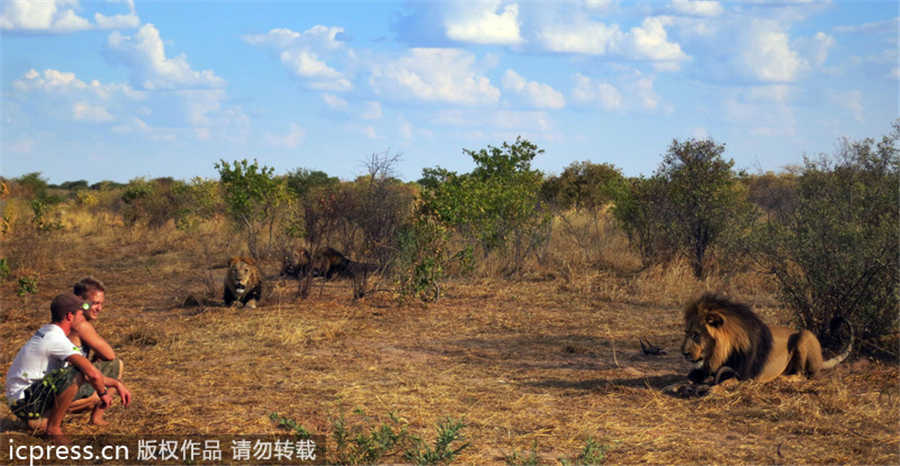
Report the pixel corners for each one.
[0,0,900,183]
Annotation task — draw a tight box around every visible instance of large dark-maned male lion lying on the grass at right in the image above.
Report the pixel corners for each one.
[681,293,853,384]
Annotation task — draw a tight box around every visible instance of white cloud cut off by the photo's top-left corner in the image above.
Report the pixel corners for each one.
[0,0,140,34]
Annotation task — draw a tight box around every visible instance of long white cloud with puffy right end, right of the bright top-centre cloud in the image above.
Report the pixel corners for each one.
[537,17,689,69]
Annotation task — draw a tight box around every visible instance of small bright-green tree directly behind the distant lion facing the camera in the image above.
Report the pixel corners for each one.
[215,159,286,258]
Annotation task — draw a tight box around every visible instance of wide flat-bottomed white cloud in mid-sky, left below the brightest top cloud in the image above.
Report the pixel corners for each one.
[369,48,500,105]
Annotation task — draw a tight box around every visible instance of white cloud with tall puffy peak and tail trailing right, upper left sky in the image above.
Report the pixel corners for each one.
[107,24,225,90]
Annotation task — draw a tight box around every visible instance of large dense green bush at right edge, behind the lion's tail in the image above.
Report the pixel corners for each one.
[753,120,900,352]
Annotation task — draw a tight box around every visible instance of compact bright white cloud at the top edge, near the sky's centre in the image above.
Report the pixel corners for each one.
[444,0,522,45]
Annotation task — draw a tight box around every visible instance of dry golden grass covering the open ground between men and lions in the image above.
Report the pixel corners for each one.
[0,214,900,464]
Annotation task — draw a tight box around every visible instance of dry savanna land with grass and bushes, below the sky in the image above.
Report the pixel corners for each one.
[0,125,900,464]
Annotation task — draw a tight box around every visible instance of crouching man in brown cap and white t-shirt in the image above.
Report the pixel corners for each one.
[6,293,131,443]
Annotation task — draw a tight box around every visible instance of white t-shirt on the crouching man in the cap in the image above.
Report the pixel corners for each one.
[6,324,81,403]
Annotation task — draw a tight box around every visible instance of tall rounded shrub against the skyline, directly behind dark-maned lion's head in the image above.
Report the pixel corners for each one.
[614,139,754,278]
